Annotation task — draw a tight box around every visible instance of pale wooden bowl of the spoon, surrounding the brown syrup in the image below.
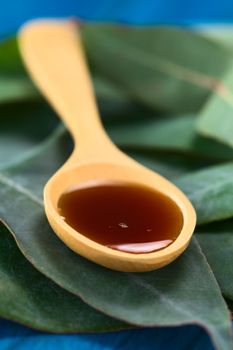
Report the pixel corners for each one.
[44,158,195,272]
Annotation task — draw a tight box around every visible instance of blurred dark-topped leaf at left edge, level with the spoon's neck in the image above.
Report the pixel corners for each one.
[0,101,58,169]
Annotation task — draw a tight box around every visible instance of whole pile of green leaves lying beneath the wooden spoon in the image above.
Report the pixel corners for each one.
[0,24,233,350]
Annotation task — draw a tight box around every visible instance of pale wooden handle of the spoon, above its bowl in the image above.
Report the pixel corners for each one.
[18,20,113,153]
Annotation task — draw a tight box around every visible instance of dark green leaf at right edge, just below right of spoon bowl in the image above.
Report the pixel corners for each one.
[197,220,233,302]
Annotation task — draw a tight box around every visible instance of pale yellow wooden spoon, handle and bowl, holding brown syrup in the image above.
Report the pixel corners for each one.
[19,20,196,272]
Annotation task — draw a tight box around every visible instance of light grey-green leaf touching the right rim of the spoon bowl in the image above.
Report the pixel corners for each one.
[175,163,233,224]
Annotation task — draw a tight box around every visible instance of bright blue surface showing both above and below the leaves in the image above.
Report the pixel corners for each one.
[0,0,233,350]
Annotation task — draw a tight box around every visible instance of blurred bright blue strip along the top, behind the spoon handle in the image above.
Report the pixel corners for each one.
[0,0,233,35]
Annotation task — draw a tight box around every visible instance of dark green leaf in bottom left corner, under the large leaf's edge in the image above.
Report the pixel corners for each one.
[0,223,128,332]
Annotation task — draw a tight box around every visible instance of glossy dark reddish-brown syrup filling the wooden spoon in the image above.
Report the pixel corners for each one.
[58,182,183,253]
